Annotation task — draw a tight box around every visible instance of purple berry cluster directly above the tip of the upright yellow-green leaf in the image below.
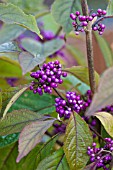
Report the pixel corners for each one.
[55,92,84,119]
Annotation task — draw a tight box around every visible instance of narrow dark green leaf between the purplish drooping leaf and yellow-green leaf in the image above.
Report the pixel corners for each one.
[36,135,58,165]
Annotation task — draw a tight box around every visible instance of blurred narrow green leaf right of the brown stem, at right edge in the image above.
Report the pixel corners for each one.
[94,34,113,67]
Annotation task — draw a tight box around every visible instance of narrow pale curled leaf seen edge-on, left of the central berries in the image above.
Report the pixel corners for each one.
[3,87,28,117]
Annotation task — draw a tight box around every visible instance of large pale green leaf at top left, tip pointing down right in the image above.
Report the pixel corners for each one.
[0,3,40,34]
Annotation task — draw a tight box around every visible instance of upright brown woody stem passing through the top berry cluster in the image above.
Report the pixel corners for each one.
[81,0,96,95]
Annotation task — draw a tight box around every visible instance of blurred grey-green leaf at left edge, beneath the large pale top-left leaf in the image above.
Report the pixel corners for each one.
[0,24,25,44]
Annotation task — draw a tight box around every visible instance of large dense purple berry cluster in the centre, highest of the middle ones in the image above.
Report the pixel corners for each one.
[30,60,67,95]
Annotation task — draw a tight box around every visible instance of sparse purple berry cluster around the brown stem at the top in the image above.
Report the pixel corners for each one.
[70,9,106,35]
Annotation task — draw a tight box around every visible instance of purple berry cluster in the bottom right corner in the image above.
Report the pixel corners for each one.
[87,138,113,170]
